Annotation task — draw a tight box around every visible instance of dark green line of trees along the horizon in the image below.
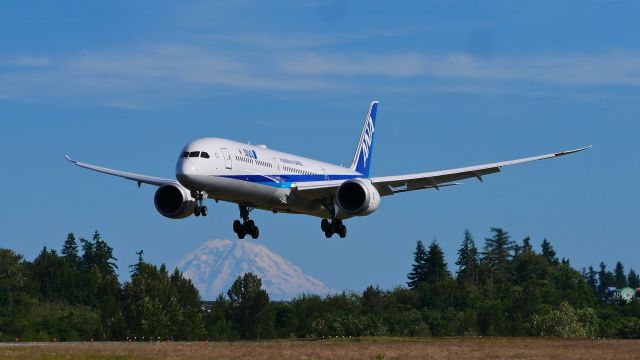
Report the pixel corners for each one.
[0,228,640,341]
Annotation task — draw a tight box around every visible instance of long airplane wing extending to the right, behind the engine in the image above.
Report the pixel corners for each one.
[293,146,591,199]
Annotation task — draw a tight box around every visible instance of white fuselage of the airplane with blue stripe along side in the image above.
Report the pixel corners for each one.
[176,138,362,217]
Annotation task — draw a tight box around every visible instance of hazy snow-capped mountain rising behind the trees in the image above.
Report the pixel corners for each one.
[177,240,333,300]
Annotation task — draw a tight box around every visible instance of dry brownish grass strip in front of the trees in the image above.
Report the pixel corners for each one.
[0,338,640,360]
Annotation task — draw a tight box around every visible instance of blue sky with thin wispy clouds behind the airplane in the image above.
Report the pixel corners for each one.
[0,0,640,296]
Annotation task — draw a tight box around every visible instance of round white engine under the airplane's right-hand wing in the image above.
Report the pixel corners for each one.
[336,179,380,216]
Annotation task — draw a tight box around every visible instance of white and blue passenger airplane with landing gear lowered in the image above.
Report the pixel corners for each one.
[66,101,591,239]
